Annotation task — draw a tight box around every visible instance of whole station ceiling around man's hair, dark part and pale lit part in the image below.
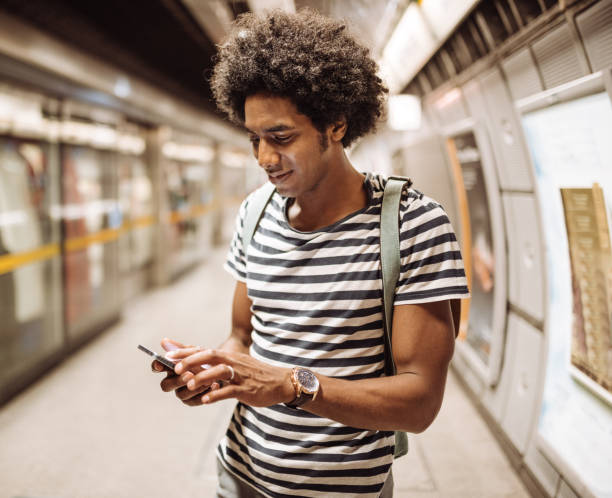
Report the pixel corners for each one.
[0,0,408,118]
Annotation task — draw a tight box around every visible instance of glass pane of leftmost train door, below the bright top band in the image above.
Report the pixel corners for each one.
[0,137,63,391]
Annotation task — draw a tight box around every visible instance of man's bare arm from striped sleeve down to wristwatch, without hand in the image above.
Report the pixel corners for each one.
[304,301,455,432]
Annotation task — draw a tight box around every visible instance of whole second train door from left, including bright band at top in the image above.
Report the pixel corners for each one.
[61,102,123,343]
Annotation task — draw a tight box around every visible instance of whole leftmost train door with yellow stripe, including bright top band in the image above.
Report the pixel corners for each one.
[0,86,64,400]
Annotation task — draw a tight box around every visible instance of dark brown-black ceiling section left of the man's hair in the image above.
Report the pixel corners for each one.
[0,0,249,112]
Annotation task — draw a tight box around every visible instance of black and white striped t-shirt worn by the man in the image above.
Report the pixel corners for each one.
[218,174,468,498]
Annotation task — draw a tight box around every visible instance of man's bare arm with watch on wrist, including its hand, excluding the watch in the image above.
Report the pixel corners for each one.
[177,301,455,432]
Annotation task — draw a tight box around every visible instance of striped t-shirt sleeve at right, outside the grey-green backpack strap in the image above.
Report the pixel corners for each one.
[394,190,470,305]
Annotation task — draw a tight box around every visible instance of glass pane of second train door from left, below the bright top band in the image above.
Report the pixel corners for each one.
[62,144,122,336]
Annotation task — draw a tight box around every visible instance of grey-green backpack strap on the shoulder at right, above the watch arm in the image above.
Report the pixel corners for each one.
[380,176,412,458]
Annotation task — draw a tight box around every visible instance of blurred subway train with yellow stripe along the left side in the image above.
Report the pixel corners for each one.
[0,12,262,408]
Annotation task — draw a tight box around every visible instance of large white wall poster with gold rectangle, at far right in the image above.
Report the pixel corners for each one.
[523,85,612,497]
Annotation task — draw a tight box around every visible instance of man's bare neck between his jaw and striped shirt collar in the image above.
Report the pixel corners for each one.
[287,153,368,231]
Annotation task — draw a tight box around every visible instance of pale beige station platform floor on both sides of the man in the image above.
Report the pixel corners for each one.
[0,250,529,498]
